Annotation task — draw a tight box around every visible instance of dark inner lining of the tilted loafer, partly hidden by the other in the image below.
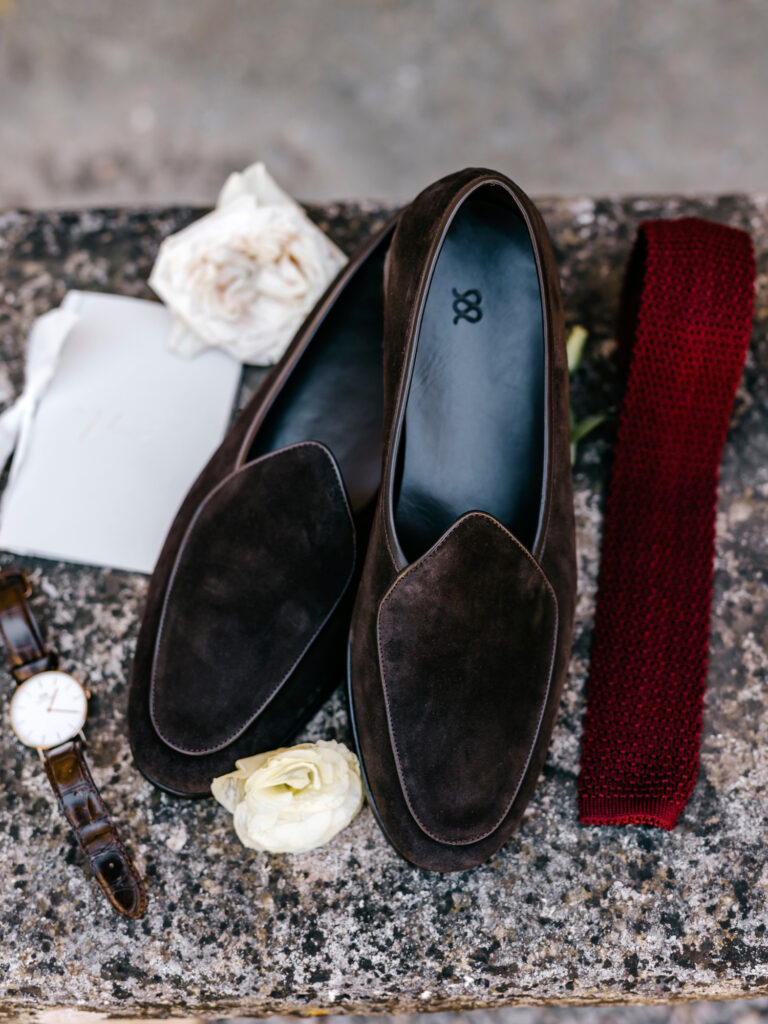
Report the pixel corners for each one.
[249,237,388,512]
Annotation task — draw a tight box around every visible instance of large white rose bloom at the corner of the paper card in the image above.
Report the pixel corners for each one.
[150,164,346,366]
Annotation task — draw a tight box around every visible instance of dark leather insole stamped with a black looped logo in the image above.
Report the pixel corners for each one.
[394,198,545,561]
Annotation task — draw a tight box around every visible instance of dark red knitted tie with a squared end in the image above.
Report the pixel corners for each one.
[579,217,755,829]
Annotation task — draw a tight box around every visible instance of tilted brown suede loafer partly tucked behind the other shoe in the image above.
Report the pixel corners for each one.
[128,211,394,797]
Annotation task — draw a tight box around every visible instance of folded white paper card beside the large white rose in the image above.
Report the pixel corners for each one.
[0,292,242,572]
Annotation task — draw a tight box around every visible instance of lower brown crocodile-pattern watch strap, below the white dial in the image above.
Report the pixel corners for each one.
[43,739,146,918]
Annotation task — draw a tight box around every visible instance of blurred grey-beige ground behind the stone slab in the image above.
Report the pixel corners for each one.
[0,0,768,206]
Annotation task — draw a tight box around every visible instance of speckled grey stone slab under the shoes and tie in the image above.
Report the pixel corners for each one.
[0,197,768,1020]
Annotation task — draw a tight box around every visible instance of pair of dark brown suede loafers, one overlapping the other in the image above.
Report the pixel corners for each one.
[129,169,575,870]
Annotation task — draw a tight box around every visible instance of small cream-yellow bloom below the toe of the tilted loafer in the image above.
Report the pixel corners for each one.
[211,739,362,853]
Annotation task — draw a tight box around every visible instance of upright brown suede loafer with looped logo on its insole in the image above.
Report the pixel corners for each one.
[348,169,575,871]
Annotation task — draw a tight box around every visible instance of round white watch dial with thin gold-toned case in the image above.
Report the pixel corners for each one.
[9,672,88,750]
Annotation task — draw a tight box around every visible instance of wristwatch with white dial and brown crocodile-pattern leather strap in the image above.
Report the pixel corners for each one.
[0,568,146,918]
